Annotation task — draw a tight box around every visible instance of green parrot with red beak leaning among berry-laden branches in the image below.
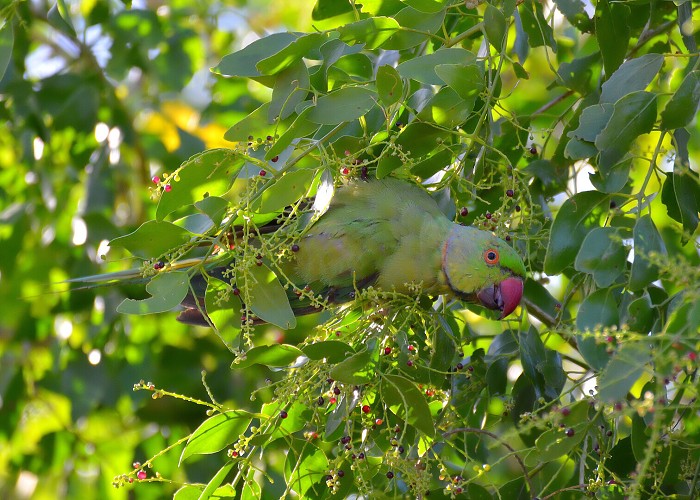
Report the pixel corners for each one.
[178,178,525,325]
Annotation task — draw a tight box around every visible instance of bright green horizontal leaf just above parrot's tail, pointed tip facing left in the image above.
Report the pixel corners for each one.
[109,220,192,259]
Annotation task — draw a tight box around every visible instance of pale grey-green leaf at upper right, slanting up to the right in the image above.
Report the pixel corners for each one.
[600,54,664,104]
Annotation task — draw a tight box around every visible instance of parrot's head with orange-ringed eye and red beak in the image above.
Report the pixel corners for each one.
[442,224,525,318]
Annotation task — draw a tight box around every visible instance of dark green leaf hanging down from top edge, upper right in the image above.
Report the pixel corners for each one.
[595,0,630,75]
